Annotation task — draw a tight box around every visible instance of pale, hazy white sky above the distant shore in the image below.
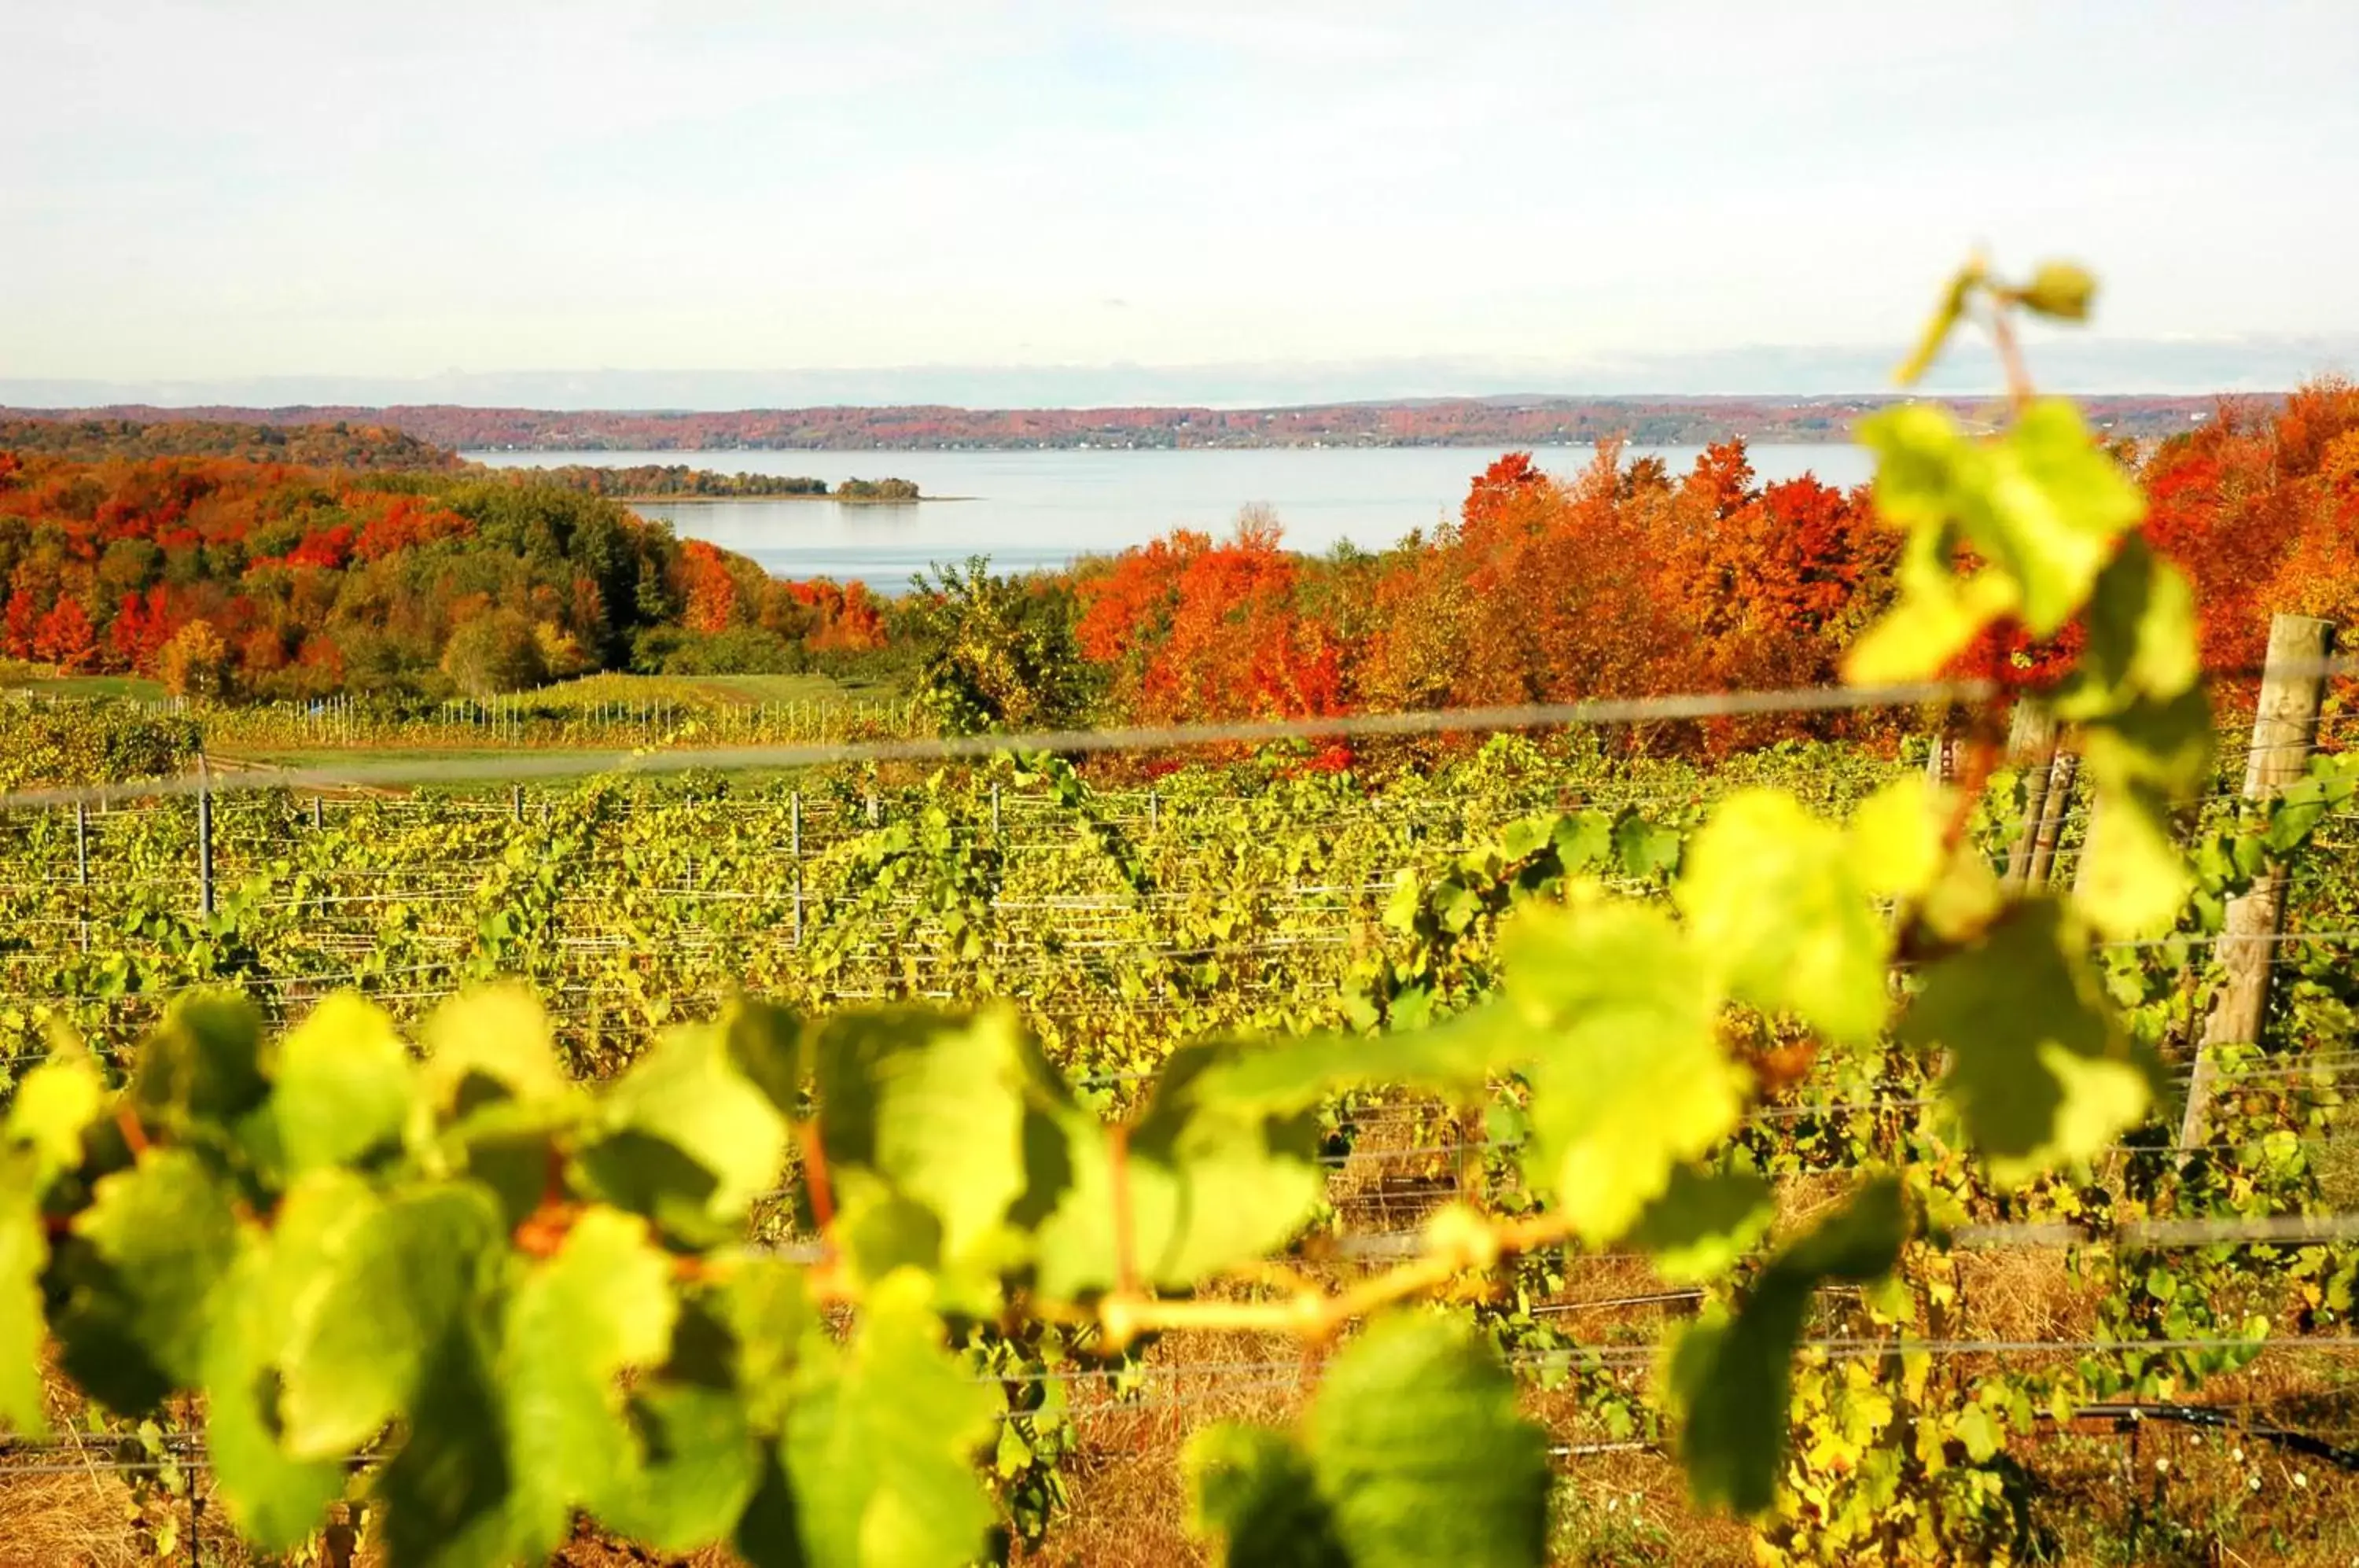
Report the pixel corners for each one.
[0,0,2359,406]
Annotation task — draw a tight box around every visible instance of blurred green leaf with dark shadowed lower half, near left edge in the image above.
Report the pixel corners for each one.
[54,1148,238,1415]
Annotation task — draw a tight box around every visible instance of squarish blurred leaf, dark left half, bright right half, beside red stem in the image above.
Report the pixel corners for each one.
[814,1009,1071,1290]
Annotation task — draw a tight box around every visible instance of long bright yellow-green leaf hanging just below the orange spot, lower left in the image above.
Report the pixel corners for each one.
[498,1207,677,1556]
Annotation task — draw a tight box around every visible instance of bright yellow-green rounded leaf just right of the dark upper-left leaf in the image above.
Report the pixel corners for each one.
[271,990,418,1176]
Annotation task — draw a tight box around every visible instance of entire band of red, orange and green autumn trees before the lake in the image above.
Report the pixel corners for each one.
[0,382,2359,727]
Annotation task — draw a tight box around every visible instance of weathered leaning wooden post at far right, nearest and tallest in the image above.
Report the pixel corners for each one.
[2180,616,2335,1148]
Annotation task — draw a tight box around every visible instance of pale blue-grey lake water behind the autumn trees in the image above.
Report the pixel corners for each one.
[467,446,1868,592]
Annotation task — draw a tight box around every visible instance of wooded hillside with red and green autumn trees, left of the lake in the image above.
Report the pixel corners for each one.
[0,451,882,698]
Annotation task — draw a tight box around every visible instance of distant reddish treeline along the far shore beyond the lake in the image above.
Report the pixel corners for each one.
[0,396,2281,453]
